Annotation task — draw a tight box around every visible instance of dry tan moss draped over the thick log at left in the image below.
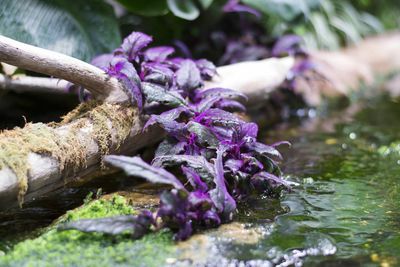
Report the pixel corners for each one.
[0,101,137,205]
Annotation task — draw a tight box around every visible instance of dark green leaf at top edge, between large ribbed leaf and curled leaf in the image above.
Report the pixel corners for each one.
[118,0,168,16]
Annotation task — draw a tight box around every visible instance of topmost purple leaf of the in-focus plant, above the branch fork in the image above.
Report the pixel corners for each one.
[114,32,153,61]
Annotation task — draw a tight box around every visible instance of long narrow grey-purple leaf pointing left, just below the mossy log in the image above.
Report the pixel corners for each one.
[104,155,184,189]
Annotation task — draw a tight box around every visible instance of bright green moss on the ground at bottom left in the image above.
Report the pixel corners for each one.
[0,196,174,266]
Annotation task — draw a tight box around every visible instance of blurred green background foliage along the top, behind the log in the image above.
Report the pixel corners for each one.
[0,0,400,61]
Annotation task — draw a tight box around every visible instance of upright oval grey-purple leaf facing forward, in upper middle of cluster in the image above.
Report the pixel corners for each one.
[176,59,202,92]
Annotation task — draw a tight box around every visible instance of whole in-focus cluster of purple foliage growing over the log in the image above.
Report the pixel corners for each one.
[63,32,287,240]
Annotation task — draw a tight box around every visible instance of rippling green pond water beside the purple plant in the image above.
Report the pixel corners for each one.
[0,96,400,267]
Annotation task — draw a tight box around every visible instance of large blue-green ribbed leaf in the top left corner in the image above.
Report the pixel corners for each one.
[0,0,121,61]
